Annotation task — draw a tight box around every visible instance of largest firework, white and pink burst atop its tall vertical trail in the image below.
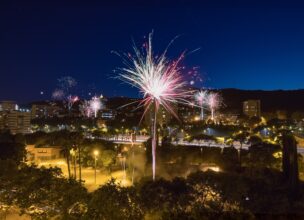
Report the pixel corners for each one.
[119,34,190,180]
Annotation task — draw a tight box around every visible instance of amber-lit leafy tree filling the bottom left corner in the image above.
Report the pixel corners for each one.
[0,164,88,219]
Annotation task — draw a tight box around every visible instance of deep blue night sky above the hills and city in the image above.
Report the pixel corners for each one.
[0,1,304,102]
